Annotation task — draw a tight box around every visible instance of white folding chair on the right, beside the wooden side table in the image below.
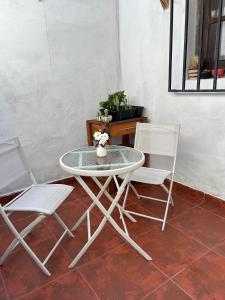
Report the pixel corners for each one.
[118,123,180,230]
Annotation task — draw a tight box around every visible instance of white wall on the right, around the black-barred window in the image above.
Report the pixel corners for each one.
[120,0,225,202]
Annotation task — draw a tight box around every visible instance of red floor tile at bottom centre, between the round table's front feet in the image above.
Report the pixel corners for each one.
[80,245,166,300]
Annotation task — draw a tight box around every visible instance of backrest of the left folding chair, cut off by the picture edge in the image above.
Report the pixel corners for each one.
[0,137,36,196]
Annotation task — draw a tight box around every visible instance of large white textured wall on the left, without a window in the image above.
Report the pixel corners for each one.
[0,0,120,182]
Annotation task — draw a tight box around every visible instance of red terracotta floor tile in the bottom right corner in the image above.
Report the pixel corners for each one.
[174,252,225,300]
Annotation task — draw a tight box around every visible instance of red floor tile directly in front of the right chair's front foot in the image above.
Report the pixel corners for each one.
[136,225,207,276]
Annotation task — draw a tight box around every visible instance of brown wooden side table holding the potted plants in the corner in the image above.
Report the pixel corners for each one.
[86,117,148,146]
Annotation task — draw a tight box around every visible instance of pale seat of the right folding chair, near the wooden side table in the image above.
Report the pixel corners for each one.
[119,167,171,184]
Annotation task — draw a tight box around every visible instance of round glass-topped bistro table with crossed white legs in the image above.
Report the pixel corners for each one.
[59,146,151,268]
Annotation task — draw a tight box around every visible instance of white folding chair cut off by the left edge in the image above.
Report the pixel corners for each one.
[0,138,73,276]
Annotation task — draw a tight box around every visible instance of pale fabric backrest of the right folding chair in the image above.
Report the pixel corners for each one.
[134,123,180,157]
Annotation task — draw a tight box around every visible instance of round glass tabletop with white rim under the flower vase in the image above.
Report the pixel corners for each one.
[60,146,144,176]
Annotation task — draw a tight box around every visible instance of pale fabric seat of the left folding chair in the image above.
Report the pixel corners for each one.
[4,184,73,215]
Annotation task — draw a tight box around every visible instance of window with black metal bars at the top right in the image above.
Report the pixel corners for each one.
[168,0,225,93]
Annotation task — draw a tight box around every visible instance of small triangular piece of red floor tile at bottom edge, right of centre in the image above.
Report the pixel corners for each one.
[144,281,192,300]
